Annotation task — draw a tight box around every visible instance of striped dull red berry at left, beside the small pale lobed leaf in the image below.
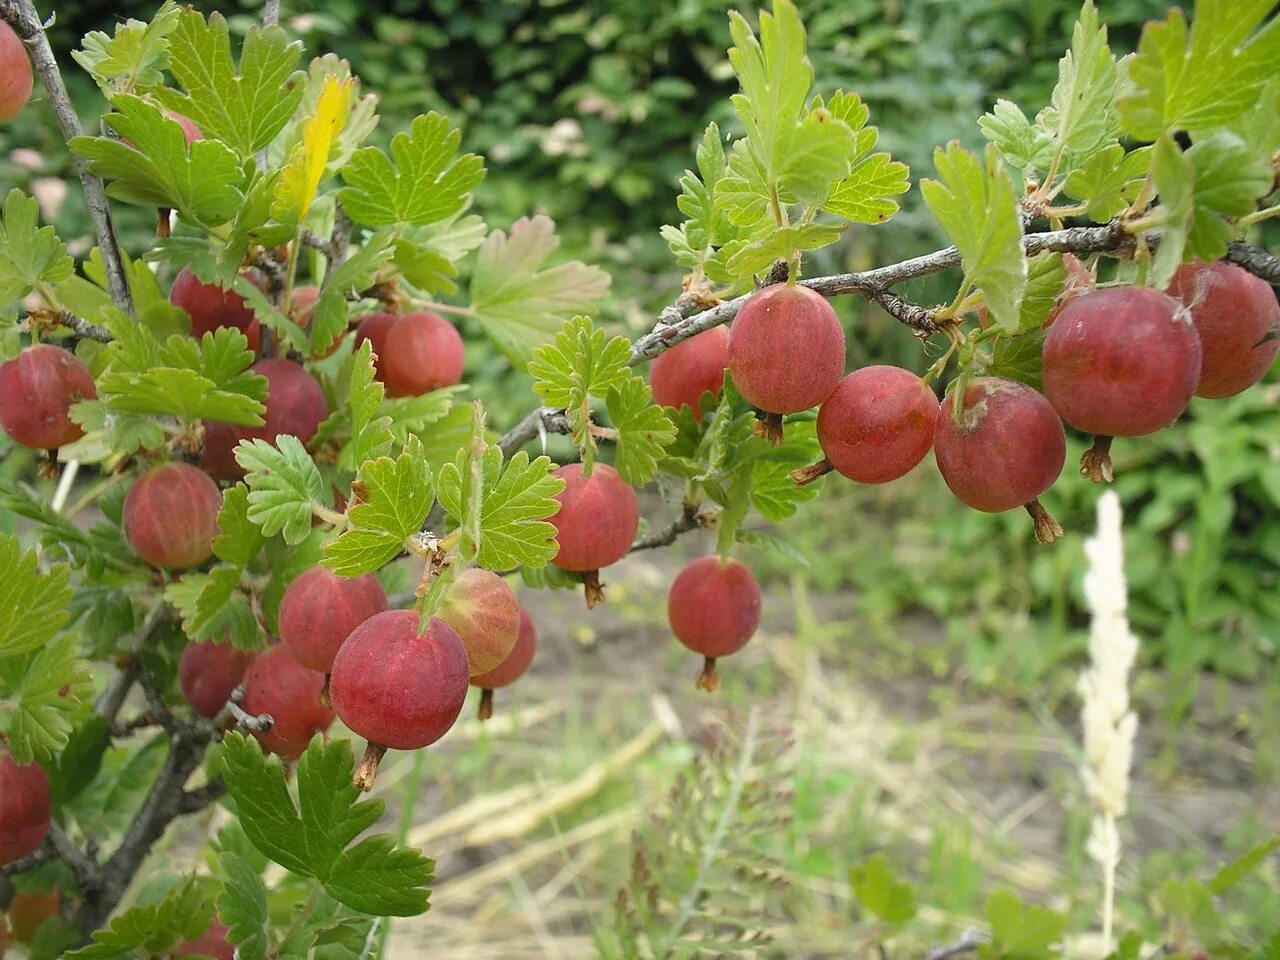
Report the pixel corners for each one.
[123,463,223,570]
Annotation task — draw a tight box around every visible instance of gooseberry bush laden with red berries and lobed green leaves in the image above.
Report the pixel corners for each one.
[0,0,1280,960]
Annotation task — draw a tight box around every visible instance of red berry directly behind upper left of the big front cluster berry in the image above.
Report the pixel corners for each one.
[279,567,387,673]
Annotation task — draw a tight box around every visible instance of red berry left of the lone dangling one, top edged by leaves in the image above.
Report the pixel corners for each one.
[549,463,640,573]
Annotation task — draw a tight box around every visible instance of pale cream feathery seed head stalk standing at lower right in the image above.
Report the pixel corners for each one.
[1076,490,1138,954]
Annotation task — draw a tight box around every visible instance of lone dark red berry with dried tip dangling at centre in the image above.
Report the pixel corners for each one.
[667,557,760,690]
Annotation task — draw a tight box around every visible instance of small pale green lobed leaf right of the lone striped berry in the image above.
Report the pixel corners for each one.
[236,434,324,544]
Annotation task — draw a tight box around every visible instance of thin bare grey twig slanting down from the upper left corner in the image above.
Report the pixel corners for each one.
[0,0,134,316]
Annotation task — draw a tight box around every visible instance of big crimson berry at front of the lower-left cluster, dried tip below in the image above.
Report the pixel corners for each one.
[329,611,471,750]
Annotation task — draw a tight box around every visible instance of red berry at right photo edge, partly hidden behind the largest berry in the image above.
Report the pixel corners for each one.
[1167,261,1280,399]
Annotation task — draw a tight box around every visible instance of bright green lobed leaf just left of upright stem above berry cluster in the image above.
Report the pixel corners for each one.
[324,436,435,577]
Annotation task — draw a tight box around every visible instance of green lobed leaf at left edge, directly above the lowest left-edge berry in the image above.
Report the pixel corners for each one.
[0,634,93,763]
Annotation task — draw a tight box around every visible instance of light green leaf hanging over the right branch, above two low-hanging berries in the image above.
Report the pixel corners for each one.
[920,141,1027,332]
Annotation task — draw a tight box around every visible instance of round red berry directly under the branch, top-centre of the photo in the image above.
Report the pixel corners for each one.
[728,289,845,413]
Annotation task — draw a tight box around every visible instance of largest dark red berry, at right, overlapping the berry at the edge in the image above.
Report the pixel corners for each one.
[1043,288,1201,436]
